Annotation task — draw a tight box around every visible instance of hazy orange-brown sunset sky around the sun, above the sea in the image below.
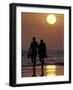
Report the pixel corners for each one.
[21,12,64,50]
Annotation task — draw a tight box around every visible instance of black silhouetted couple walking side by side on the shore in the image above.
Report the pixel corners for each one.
[28,37,47,76]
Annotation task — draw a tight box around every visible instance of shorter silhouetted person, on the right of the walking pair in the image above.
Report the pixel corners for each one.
[38,40,47,76]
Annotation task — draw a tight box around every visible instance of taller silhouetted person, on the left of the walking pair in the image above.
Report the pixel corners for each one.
[28,37,38,76]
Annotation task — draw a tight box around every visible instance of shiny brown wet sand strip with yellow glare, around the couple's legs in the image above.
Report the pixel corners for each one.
[21,65,64,77]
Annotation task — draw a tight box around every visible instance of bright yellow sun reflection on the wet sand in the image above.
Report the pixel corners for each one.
[46,65,56,76]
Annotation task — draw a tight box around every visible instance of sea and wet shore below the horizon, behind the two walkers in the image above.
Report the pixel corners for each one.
[21,52,64,77]
